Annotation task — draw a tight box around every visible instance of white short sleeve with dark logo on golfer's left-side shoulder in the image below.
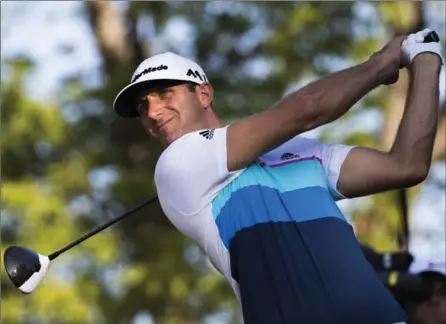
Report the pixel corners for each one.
[155,127,239,216]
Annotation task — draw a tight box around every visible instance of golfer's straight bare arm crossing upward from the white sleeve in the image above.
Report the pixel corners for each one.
[227,37,404,171]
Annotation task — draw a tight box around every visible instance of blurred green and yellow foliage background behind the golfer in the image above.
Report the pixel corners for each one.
[1,1,446,324]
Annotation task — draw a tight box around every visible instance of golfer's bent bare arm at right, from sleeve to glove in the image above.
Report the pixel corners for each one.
[338,39,441,198]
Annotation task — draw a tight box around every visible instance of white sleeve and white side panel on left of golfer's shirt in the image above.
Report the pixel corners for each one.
[155,127,243,301]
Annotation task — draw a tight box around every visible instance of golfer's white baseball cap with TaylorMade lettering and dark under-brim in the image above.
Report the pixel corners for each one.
[113,52,208,118]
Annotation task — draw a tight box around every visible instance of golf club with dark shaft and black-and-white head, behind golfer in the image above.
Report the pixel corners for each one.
[4,196,158,294]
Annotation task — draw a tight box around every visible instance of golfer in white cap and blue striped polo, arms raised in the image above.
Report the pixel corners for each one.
[114,30,441,324]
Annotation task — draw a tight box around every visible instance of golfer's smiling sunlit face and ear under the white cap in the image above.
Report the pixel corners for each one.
[138,81,212,146]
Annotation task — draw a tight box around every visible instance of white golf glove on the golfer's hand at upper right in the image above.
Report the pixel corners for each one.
[401,28,444,65]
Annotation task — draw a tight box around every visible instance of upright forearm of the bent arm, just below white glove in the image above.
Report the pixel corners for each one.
[391,59,440,177]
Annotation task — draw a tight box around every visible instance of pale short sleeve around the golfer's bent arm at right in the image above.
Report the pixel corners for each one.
[319,142,354,200]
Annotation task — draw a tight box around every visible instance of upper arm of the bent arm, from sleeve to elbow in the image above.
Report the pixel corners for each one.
[337,147,423,198]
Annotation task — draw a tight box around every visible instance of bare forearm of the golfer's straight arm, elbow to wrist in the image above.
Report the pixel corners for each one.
[277,59,381,132]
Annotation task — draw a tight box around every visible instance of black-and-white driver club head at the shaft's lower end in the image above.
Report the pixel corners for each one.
[4,246,50,294]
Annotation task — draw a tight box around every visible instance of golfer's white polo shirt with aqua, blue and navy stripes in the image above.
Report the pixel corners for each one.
[155,127,405,324]
